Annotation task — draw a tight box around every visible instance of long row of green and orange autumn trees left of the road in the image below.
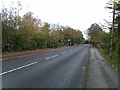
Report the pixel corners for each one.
[0,2,83,52]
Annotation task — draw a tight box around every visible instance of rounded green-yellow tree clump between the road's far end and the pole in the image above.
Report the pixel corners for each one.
[87,23,111,56]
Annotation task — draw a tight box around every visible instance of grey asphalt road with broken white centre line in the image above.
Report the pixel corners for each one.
[0,45,90,88]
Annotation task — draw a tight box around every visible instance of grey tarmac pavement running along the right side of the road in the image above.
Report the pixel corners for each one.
[86,47,119,89]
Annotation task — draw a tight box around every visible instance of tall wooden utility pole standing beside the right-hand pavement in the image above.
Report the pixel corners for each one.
[109,0,115,60]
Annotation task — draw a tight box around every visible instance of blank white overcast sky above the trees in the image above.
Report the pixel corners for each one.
[0,0,110,38]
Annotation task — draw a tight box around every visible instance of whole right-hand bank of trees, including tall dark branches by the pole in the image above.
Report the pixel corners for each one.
[88,0,120,72]
